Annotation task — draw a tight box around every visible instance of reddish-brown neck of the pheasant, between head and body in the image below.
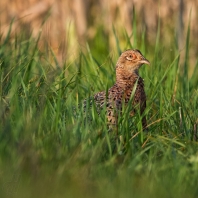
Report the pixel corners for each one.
[116,68,140,89]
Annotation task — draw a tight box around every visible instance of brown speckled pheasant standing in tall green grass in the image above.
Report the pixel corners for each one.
[84,49,150,129]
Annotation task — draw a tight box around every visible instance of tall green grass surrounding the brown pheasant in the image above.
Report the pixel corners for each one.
[0,21,198,198]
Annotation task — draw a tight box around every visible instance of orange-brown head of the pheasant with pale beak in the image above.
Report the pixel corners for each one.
[116,49,150,73]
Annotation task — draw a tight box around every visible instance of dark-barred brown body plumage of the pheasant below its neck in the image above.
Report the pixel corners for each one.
[94,73,147,128]
